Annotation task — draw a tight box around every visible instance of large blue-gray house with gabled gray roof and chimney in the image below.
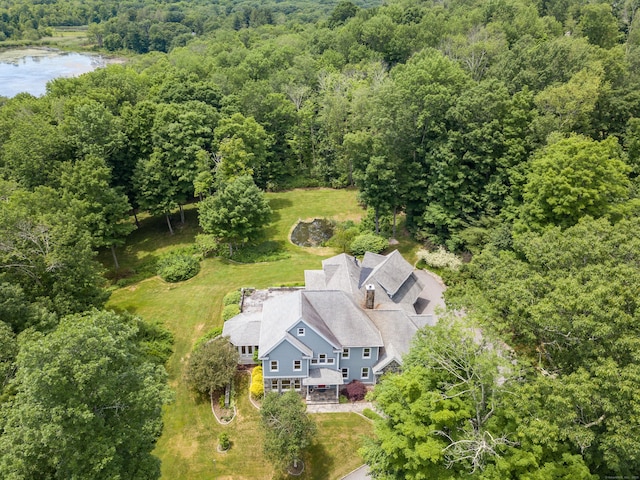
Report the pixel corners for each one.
[223,251,444,402]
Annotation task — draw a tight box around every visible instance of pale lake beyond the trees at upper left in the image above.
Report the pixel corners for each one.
[0,48,108,97]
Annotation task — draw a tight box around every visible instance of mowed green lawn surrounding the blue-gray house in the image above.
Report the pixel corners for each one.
[101,189,372,479]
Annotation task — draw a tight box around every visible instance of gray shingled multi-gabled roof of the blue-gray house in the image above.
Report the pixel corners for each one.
[251,251,444,372]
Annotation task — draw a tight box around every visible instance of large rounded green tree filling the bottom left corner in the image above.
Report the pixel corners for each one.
[0,311,171,479]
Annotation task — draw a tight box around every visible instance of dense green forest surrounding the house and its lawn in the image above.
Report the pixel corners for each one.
[0,0,640,479]
